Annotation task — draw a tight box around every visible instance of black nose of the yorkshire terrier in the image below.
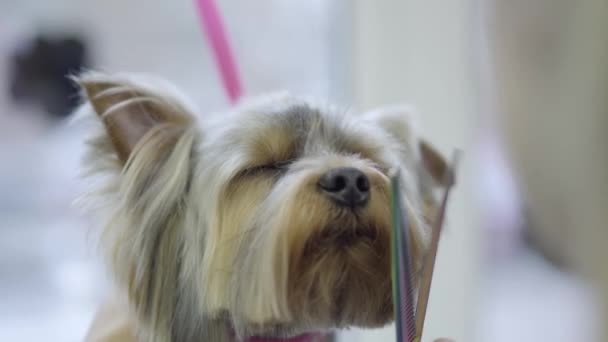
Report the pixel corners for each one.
[319,167,369,208]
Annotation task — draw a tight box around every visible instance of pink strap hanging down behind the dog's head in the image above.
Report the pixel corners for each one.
[195,0,243,103]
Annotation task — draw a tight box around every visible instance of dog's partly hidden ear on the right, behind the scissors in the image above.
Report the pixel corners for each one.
[365,106,449,185]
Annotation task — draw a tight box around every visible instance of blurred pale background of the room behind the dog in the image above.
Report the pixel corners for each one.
[0,0,608,342]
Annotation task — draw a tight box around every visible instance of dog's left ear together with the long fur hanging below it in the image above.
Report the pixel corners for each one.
[75,73,199,341]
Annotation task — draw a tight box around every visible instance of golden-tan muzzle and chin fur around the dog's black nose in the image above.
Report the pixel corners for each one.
[233,164,392,334]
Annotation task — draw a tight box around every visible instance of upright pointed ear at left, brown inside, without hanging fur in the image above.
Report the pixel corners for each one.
[75,73,193,164]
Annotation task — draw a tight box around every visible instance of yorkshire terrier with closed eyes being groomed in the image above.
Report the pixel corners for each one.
[76,73,447,342]
